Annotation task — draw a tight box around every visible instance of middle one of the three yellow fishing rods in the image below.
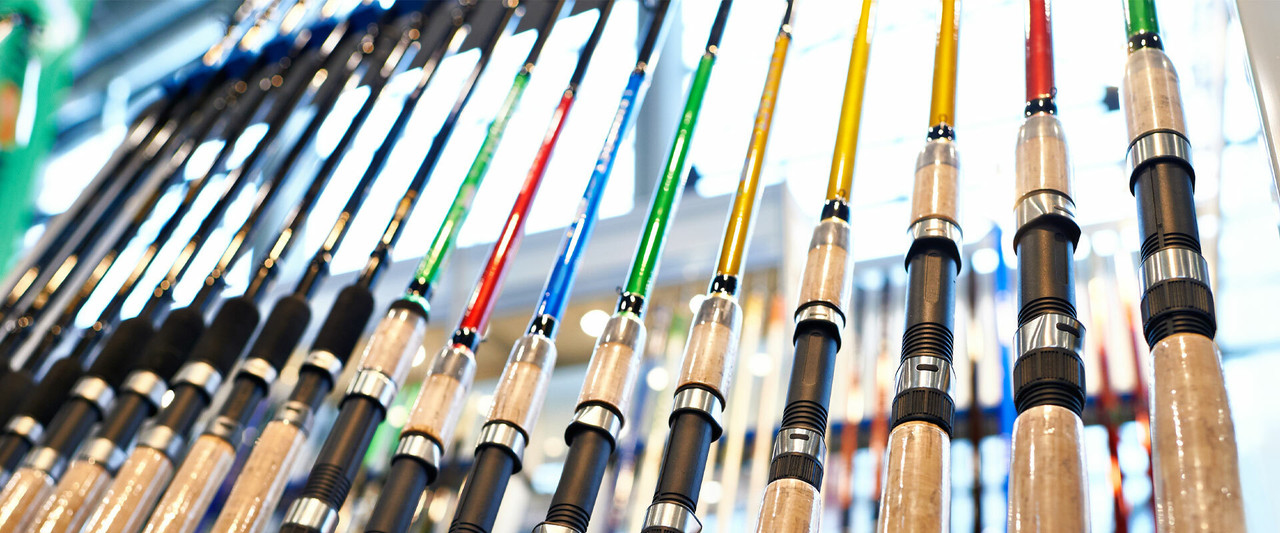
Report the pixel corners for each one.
[756,0,874,532]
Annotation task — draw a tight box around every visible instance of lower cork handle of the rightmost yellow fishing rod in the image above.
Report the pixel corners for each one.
[876,422,951,533]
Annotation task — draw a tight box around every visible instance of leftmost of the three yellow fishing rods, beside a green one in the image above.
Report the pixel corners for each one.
[643,5,795,533]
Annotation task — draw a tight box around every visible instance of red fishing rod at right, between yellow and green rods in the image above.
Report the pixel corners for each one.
[1009,0,1090,532]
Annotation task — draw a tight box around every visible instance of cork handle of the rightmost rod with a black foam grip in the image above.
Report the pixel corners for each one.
[211,420,307,533]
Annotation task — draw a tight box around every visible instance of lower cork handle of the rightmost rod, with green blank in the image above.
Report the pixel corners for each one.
[1151,333,1244,533]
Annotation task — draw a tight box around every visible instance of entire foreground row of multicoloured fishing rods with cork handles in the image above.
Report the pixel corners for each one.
[0,0,1243,533]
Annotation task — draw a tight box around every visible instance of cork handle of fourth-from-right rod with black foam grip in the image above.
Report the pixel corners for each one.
[32,460,111,533]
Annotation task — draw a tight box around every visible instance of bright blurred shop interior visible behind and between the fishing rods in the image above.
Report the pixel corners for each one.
[0,0,1280,532]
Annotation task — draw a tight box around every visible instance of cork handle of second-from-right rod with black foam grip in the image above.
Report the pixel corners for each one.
[143,434,236,533]
